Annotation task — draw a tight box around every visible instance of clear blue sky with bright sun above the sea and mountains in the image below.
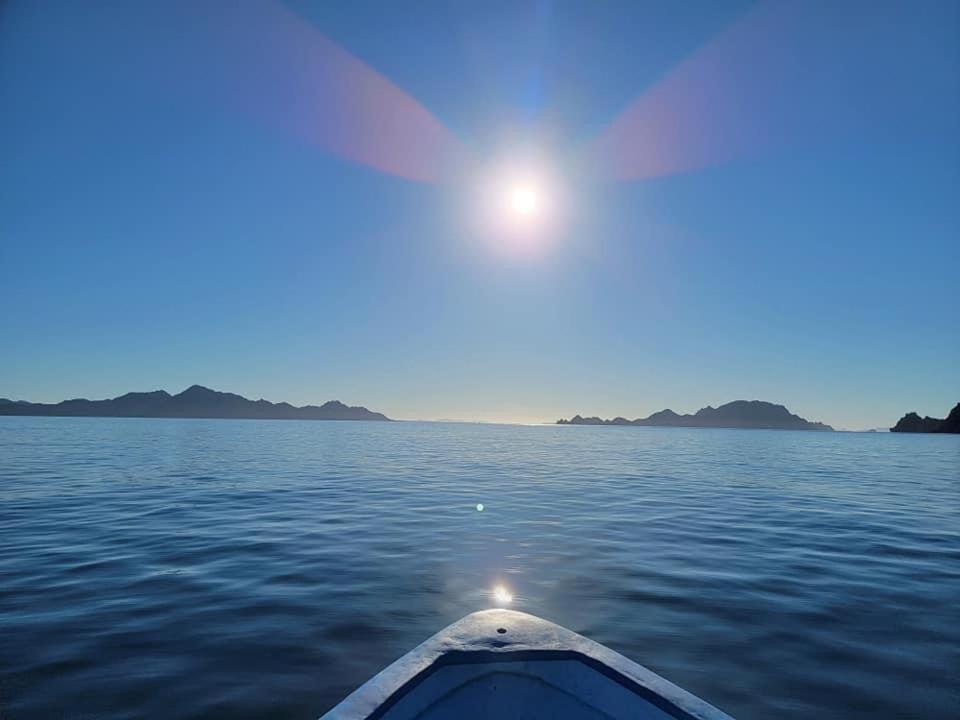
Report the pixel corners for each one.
[0,0,960,428]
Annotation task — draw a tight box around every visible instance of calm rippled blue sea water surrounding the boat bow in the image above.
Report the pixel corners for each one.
[0,418,960,720]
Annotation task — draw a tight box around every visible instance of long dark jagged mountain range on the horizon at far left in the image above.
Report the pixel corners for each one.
[0,385,390,420]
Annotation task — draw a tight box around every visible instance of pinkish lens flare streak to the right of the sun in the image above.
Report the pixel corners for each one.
[586,2,888,180]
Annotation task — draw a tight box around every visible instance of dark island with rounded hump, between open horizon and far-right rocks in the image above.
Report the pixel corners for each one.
[557,400,833,430]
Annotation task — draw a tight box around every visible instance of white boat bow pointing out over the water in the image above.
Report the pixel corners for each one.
[322,610,731,720]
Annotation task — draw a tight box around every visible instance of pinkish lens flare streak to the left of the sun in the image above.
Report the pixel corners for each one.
[194,0,469,182]
